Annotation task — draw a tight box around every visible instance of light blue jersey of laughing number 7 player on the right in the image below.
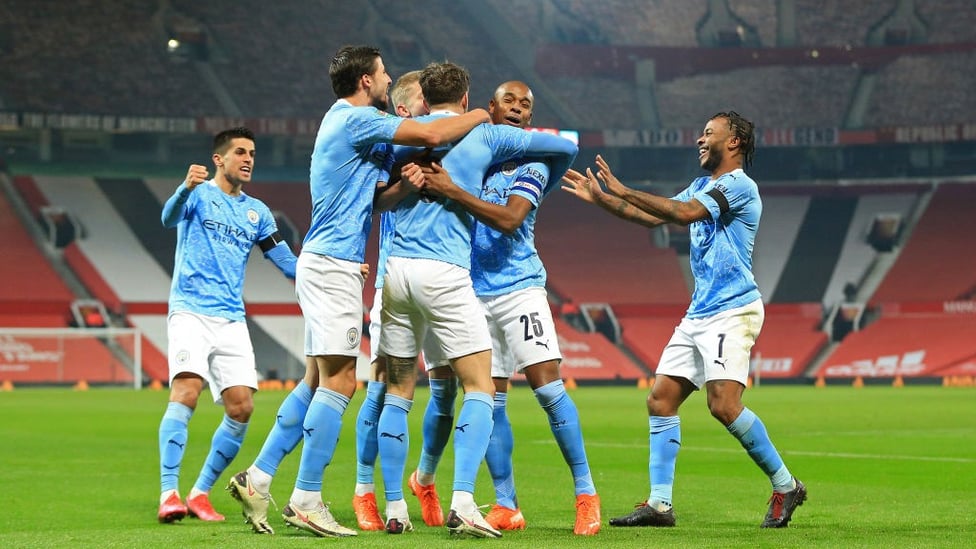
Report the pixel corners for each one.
[674,169,762,318]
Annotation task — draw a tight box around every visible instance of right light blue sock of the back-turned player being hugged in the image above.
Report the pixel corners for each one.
[454,392,492,494]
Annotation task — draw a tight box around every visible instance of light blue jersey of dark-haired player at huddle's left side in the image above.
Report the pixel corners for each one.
[302,99,404,263]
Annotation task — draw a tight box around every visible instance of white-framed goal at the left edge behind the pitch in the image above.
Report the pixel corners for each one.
[0,327,142,389]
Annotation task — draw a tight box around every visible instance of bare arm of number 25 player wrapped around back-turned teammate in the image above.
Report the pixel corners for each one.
[418,163,532,235]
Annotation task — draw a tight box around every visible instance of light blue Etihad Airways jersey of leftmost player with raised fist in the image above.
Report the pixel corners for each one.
[167,180,278,321]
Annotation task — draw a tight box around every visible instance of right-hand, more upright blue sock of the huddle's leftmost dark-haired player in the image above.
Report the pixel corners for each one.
[295,387,349,492]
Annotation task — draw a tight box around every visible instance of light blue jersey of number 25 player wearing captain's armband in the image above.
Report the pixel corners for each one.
[471,159,555,297]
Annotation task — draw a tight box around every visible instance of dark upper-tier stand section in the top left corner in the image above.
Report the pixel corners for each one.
[0,0,220,116]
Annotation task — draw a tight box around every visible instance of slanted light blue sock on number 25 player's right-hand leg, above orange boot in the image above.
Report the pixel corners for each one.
[534,379,596,496]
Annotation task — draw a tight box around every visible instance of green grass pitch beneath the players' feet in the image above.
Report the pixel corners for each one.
[0,386,976,549]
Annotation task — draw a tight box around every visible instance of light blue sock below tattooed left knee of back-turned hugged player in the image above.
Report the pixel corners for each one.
[377,393,413,502]
